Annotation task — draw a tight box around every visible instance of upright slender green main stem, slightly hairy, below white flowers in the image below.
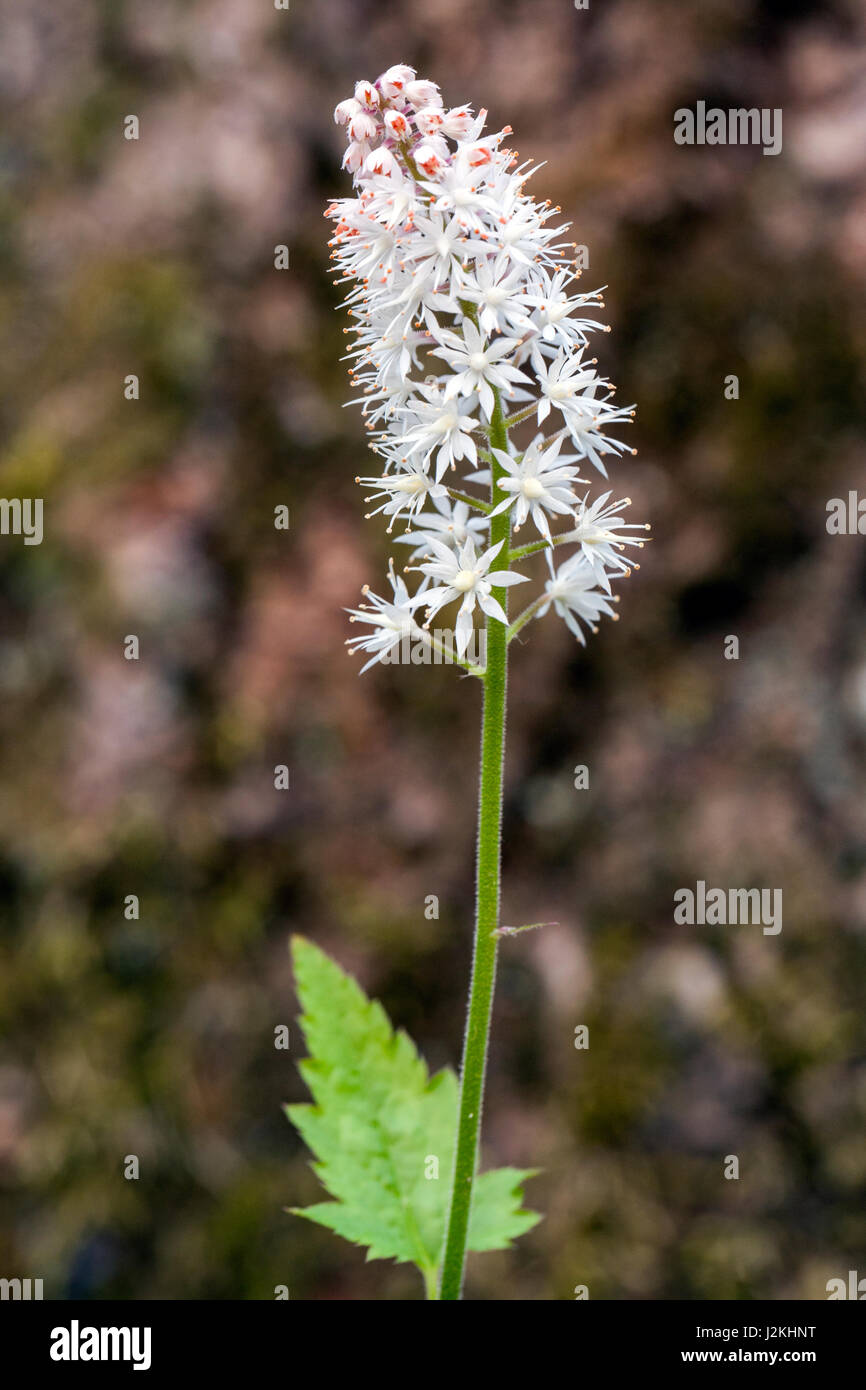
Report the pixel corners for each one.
[439,392,510,1300]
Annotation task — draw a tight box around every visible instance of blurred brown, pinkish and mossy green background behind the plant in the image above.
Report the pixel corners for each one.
[0,0,866,1300]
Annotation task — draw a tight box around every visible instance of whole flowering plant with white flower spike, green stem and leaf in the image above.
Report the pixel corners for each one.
[291,64,648,1298]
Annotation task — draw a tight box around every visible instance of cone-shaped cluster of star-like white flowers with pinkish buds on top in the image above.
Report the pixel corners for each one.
[327,64,649,670]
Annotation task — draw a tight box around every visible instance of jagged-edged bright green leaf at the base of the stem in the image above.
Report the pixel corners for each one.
[285,937,539,1291]
